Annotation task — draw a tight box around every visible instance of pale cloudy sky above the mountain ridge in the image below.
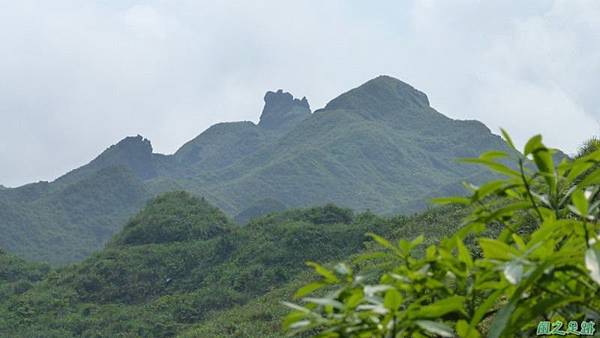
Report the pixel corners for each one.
[0,0,600,186]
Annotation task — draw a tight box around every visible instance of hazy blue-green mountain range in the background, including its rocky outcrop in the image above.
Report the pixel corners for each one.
[0,76,507,264]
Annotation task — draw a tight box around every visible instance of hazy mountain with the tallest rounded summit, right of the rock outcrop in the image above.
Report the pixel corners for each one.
[203,77,506,213]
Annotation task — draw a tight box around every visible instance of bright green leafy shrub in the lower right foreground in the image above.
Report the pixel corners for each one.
[284,133,600,338]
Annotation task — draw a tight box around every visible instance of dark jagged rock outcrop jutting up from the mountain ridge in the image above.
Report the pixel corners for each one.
[258,89,310,129]
